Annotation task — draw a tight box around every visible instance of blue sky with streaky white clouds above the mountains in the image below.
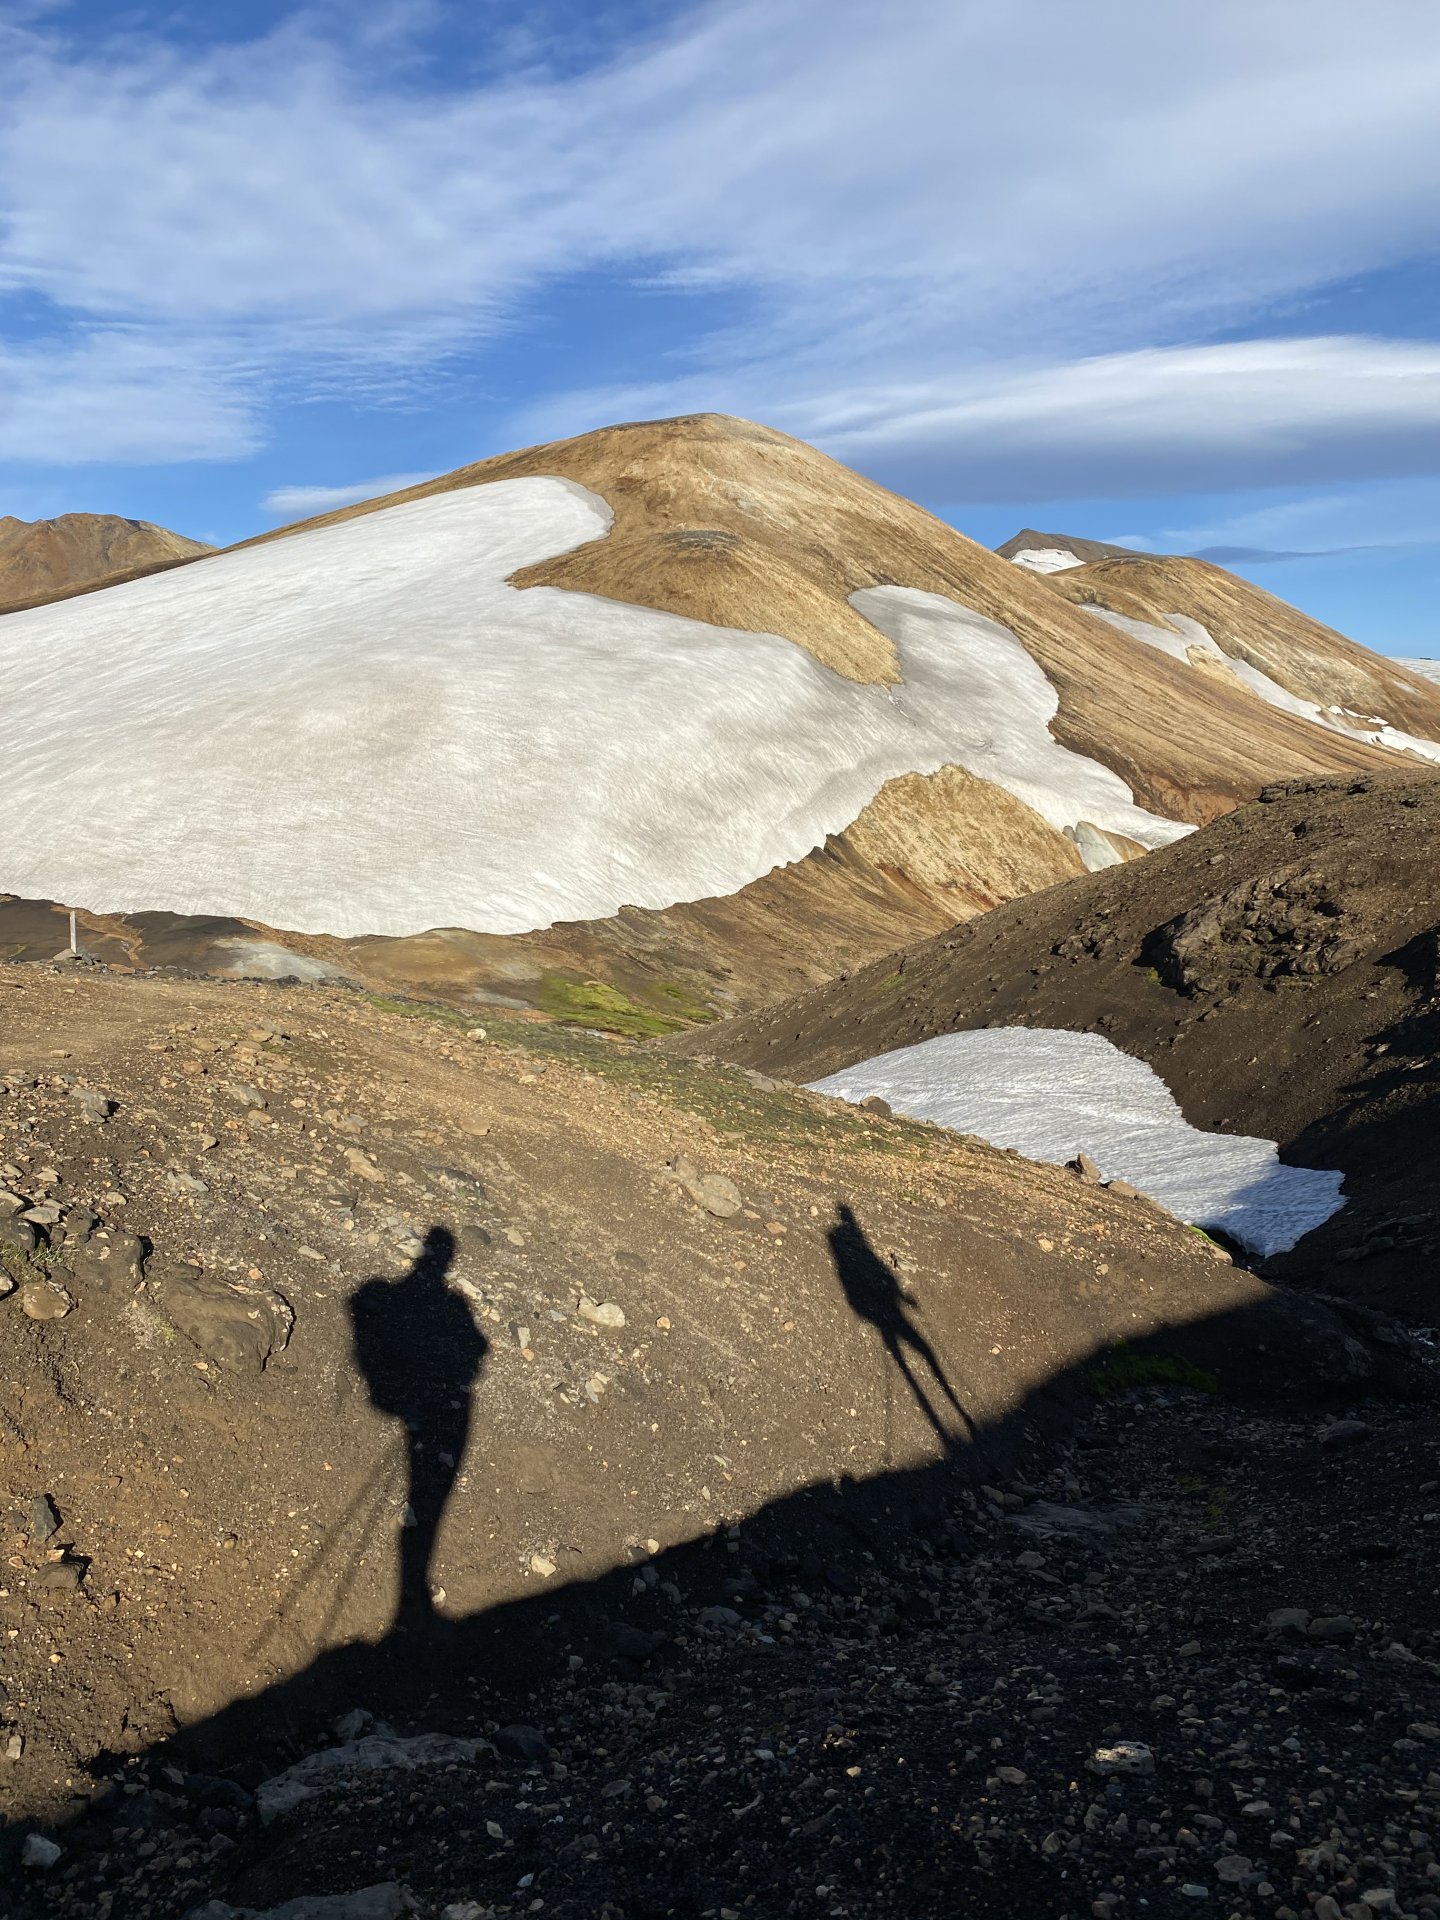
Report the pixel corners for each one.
[0,0,1440,653]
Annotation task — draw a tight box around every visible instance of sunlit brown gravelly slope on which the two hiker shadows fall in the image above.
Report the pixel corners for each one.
[0,966,1388,1827]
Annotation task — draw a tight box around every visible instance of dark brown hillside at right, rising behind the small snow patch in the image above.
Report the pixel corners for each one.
[695,774,1440,1319]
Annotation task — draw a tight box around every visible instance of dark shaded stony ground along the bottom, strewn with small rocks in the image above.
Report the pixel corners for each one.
[11,1388,1440,1920]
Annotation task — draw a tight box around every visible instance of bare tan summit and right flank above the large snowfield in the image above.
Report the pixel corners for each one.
[228,415,1440,822]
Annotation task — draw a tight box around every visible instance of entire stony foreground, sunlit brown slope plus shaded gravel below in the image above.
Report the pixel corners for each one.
[0,964,1440,1920]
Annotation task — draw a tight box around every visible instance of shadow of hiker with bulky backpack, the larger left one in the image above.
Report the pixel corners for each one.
[349,1227,490,1626]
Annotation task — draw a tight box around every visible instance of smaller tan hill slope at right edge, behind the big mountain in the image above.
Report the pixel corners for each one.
[1044,553,1434,739]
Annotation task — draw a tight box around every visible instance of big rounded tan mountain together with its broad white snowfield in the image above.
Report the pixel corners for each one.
[0,415,1440,968]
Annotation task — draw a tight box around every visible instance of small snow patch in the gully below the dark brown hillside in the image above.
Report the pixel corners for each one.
[814,1027,1344,1256]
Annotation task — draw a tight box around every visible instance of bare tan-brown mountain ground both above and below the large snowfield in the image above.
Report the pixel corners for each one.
[0,415,1440,1025]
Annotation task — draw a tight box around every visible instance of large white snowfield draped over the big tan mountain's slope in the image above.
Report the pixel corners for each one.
[0,478,1188,935]
